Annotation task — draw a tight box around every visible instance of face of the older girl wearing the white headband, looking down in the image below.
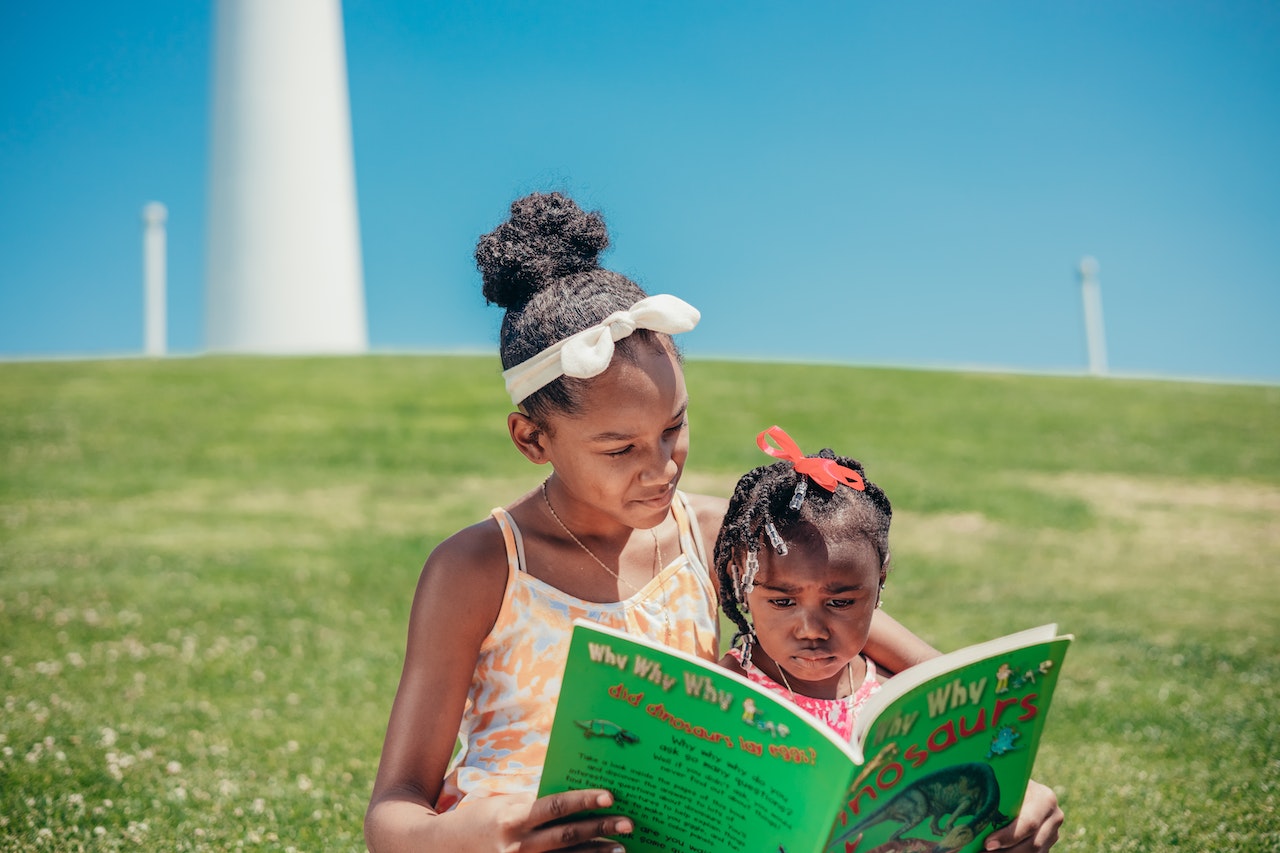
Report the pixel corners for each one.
[541,347,689,534]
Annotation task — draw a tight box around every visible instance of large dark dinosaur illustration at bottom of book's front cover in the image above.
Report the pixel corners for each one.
[835,763,1010,853]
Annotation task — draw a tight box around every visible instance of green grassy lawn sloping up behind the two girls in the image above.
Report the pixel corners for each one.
[0,356,1280,853]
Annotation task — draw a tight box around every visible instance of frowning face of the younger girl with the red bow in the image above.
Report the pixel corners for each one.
[748,523,884,699]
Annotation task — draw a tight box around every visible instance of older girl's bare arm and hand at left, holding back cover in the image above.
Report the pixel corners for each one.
[365,524,632,853]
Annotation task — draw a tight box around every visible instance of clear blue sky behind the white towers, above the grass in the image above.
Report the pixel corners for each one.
[0,0,1280,383]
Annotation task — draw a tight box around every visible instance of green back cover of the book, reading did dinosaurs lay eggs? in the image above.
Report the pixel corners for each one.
[539,622,855,853]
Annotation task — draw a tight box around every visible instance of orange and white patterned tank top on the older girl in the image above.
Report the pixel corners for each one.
[436,492,719,812]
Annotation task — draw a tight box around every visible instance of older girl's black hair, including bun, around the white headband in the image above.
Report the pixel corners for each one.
[476,192,678,421]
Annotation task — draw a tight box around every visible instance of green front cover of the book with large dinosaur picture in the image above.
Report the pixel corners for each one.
[826,625,1071,853]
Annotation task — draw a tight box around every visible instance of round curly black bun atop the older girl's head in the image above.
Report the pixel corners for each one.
[476,192,609,309]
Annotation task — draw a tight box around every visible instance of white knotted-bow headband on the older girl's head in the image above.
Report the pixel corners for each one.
[502,293,701,406]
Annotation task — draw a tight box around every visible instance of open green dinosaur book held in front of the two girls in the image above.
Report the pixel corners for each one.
[539,621,1071,853]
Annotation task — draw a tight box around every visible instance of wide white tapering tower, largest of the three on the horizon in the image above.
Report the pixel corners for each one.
[205,0,369,353]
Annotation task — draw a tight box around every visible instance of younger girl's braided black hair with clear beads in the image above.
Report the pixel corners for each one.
[713,448,893,640]
